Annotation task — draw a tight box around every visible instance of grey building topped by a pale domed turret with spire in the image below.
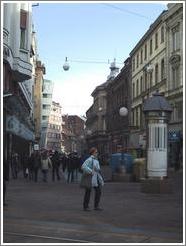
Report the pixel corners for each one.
[86,59,119,163]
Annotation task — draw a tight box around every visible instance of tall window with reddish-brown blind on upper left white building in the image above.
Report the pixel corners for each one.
[20,9,27,49]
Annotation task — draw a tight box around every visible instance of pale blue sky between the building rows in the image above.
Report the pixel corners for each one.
[32,1,167,116]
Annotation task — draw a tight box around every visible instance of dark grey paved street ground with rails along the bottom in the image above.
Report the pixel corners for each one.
[3,167,183,244]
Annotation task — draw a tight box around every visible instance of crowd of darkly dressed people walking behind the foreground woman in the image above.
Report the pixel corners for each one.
[10,150,82,183]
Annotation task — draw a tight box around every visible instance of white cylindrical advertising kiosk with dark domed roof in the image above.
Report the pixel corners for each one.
[143,92,172,191]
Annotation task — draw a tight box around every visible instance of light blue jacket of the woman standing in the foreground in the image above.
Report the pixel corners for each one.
[81,155,104,187]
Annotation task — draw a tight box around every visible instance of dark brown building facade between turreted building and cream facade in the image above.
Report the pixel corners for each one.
[106,58,131,154]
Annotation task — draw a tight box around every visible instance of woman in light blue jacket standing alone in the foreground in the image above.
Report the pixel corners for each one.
[82,147,104,211]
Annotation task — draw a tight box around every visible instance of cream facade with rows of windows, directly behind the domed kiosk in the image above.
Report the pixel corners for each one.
[130,11,167,149]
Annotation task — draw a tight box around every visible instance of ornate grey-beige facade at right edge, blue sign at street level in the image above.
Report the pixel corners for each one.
[165,3,183,168]
